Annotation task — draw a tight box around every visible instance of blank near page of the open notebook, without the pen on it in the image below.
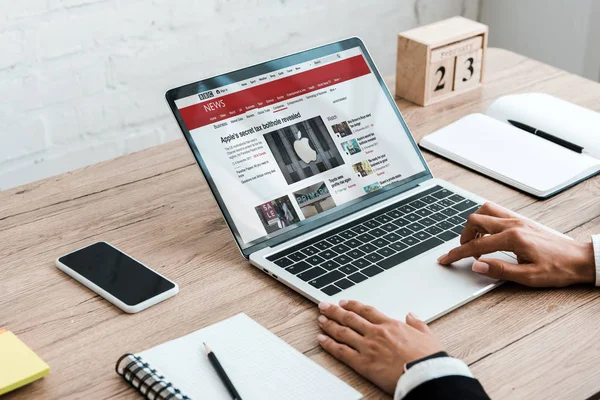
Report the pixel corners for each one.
[421,114,600,196]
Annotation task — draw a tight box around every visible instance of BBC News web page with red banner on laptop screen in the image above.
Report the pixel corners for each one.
[175,48,424,243]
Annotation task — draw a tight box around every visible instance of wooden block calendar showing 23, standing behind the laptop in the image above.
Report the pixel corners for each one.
[396,17,488,106]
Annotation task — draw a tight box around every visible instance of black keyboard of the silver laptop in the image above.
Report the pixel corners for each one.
[267,186,480,296]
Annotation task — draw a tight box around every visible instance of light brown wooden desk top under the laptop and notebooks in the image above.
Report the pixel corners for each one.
[0,49,600,399]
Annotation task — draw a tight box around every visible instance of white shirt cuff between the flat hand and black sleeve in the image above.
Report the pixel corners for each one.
[394,357,473,400]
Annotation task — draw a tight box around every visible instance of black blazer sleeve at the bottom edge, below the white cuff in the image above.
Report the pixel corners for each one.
[403,375,490,400]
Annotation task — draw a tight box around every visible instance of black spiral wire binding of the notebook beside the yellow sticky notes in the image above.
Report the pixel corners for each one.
[115,353,191,400]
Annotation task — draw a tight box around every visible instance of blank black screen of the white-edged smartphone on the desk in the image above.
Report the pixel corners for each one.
[59,242,175,306]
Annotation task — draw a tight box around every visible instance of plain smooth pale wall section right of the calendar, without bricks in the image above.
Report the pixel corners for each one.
[481,0,600,81]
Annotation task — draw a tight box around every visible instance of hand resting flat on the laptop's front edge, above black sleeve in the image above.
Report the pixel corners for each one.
[317,300,443,394]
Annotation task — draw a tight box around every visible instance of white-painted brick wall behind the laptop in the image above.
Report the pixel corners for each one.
[0,0,479,190]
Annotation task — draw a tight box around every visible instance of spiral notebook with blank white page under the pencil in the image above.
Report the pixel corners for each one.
[116,314,362,400]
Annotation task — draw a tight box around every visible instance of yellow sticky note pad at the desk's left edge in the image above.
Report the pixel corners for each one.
[0,330,50,395]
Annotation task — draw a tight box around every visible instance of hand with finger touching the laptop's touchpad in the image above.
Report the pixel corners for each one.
[438,203,596,287]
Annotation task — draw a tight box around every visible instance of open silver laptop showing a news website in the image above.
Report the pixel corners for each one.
[166,38,516,321]
